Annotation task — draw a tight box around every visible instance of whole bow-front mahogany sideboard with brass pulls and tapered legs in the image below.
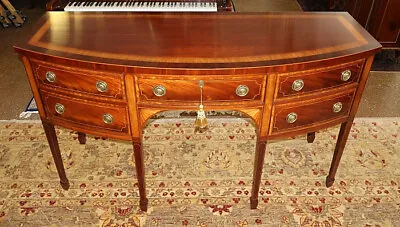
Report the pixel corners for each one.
[14,12,381,210]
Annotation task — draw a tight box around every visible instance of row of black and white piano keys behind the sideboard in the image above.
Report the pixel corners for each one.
[64,1,217,12]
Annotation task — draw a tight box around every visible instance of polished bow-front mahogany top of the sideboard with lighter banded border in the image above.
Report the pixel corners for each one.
[15,12,381,68]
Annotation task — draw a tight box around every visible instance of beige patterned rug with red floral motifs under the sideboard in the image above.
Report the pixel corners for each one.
[0,117,400,226]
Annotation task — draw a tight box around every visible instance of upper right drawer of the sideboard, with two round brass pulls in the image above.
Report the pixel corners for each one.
[277,61,363,98]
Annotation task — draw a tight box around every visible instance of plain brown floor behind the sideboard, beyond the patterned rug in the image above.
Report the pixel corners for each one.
[0,0,400,120]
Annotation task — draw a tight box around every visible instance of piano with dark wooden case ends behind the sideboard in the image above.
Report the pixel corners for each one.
[46,0,234,12]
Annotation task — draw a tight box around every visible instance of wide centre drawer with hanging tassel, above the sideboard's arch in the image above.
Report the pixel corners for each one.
[137,75,266,102]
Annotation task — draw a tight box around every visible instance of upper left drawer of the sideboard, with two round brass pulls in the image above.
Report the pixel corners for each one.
[33,61,125,99]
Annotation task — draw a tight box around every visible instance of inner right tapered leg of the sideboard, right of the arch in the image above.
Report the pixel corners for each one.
[250,141,267,209]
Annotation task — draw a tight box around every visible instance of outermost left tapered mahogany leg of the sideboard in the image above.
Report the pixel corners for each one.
[42,122,69,190]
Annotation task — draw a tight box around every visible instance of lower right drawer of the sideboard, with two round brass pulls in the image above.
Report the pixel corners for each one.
[272,91,354,133]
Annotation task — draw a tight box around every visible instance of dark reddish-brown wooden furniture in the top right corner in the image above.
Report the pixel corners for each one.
[345,0,400,49]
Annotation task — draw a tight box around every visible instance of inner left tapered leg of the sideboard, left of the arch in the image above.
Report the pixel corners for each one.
[133,142,149,211]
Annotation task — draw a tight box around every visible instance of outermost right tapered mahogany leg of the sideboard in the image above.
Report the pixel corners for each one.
[326,120,353,187]
